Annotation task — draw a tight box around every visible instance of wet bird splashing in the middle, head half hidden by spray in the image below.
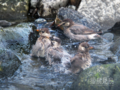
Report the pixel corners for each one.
[46,36,71,66]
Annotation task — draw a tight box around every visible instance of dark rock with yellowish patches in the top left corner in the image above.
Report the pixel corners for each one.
[0,0,29,21]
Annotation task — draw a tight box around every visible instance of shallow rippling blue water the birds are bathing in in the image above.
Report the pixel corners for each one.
[0,20,118,90]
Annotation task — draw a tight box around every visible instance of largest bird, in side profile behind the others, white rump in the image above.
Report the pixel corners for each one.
[57,19,101,41]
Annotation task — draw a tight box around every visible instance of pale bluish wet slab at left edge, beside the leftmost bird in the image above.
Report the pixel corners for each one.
[0,23,32,54]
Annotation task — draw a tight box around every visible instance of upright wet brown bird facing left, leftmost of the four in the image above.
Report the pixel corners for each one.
[31,28,51,58]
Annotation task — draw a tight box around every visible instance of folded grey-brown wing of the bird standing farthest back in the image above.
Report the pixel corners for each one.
[69,25,95,35]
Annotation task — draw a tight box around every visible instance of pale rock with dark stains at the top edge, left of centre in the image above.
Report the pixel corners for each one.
[31,0,69,17]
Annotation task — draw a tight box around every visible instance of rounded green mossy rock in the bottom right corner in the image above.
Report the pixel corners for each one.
[71,64,120,90]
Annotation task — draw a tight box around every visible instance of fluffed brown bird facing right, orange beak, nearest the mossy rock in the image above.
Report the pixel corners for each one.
[70,42,93,74]
